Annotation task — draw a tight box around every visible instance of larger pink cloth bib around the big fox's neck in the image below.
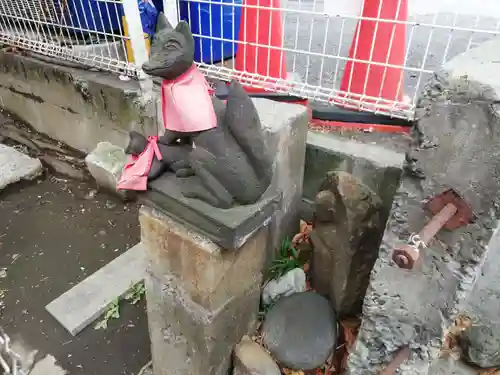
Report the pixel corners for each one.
[161,65,217,133]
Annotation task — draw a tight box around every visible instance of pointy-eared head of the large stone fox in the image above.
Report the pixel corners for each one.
[142,13,194,80]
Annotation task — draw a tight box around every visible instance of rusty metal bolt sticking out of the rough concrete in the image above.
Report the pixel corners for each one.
[392,189,476,269]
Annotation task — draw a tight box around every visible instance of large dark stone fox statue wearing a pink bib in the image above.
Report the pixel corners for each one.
[127,14,273,208]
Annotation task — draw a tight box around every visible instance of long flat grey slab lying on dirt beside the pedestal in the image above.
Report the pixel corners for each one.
[45,243,146,336]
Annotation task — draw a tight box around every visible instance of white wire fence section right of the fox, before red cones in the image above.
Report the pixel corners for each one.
[178,0,500,119]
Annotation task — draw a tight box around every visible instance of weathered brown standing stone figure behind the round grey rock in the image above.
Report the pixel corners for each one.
[310,171,384,318]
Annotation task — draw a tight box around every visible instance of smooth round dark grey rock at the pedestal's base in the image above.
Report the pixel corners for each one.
[262,292,337,370]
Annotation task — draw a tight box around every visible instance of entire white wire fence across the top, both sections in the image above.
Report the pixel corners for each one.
[0,0,500,119]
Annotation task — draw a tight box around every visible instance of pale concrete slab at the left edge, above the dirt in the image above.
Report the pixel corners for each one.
[0,144,43,190]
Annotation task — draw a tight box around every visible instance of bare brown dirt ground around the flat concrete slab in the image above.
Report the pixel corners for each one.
[0,175,150,375]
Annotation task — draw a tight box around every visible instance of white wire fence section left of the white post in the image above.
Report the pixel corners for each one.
[0,0,138,76]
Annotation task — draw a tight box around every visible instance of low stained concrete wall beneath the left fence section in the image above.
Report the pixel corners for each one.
[0,53,157,152]
